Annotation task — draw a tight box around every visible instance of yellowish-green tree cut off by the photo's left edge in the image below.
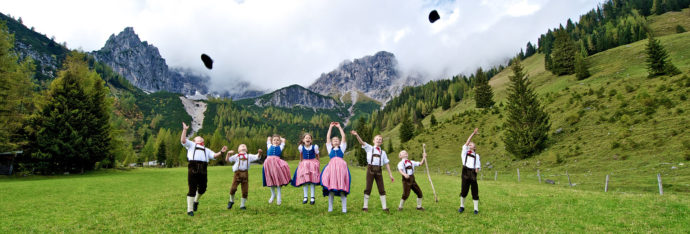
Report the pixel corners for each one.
[0,21,33,152]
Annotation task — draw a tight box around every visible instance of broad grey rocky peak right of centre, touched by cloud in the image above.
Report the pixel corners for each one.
[309,51,420,103]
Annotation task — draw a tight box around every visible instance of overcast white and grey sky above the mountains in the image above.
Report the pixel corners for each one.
[0,0,601,92]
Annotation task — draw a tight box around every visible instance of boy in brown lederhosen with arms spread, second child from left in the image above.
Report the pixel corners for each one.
[225,144,261,210]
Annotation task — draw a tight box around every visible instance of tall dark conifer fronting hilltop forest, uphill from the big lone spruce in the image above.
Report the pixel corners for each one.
[551,29,577,76]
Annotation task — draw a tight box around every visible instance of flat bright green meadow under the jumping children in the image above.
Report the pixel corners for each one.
[0,165,690,233]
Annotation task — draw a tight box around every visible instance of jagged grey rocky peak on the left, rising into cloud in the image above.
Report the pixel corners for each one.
[91,27,209,94]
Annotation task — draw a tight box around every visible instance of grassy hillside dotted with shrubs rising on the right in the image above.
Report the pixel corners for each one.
[384,14,690,192]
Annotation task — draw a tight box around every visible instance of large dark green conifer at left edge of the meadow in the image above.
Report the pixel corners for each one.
[30,52,113,173]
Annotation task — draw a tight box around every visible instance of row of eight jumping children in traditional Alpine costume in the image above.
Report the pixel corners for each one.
[181,122,481,216]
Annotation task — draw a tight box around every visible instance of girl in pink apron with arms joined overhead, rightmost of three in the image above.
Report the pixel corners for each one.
[321,122,350,213]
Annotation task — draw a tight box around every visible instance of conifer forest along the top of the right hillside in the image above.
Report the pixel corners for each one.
[532,0,690,79]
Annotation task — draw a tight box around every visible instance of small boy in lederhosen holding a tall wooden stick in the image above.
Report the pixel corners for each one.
[398,150,426,210]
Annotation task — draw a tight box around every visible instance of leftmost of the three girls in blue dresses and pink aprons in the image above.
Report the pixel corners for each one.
[262,134,290,205]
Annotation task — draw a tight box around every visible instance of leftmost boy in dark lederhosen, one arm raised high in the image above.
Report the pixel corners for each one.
[180,123,228,216]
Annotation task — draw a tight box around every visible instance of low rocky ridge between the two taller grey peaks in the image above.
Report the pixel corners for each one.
[243,85,342,109]
